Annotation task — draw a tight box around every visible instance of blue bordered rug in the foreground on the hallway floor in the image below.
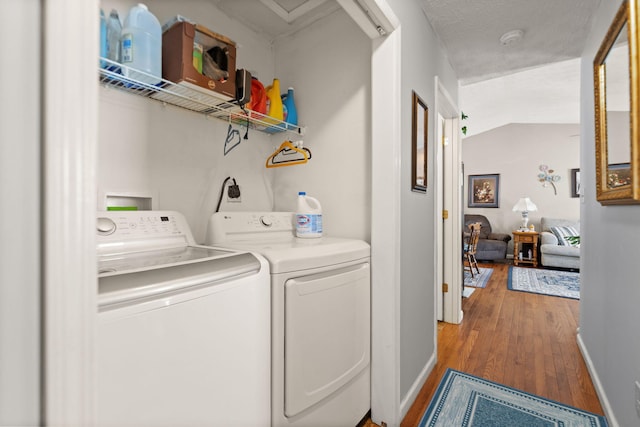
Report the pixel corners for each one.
[419,369,607,427]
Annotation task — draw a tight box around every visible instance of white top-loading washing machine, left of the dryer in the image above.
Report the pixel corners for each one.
[96,211,271,427]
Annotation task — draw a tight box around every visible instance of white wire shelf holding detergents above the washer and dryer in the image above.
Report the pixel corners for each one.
[99,58,304,135]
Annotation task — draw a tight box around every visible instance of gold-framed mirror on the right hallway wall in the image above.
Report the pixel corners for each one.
[593,0,640,205]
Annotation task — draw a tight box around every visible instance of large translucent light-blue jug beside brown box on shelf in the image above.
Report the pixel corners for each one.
[120,3,162,84]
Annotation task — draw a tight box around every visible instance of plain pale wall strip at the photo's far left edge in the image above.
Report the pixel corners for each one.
[0,0,42,426]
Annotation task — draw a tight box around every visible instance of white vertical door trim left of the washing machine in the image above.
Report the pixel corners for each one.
[41,0,99,426]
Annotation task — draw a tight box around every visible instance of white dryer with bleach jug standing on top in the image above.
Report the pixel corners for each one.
[206,212,371,427]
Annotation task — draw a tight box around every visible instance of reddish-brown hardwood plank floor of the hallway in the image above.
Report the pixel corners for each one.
[401,264,604,427]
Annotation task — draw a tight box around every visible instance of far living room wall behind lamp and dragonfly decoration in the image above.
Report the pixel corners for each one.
[462,124,580,239]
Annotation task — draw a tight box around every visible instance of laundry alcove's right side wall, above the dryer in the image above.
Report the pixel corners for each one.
[274,11,371,241]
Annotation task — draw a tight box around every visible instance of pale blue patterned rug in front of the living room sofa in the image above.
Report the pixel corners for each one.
[507,266,580,299]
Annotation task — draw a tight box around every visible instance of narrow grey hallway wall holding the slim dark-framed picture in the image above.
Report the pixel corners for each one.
[384,0,458,409]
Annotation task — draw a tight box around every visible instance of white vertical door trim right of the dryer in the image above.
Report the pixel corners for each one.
[371,27,402,426]
